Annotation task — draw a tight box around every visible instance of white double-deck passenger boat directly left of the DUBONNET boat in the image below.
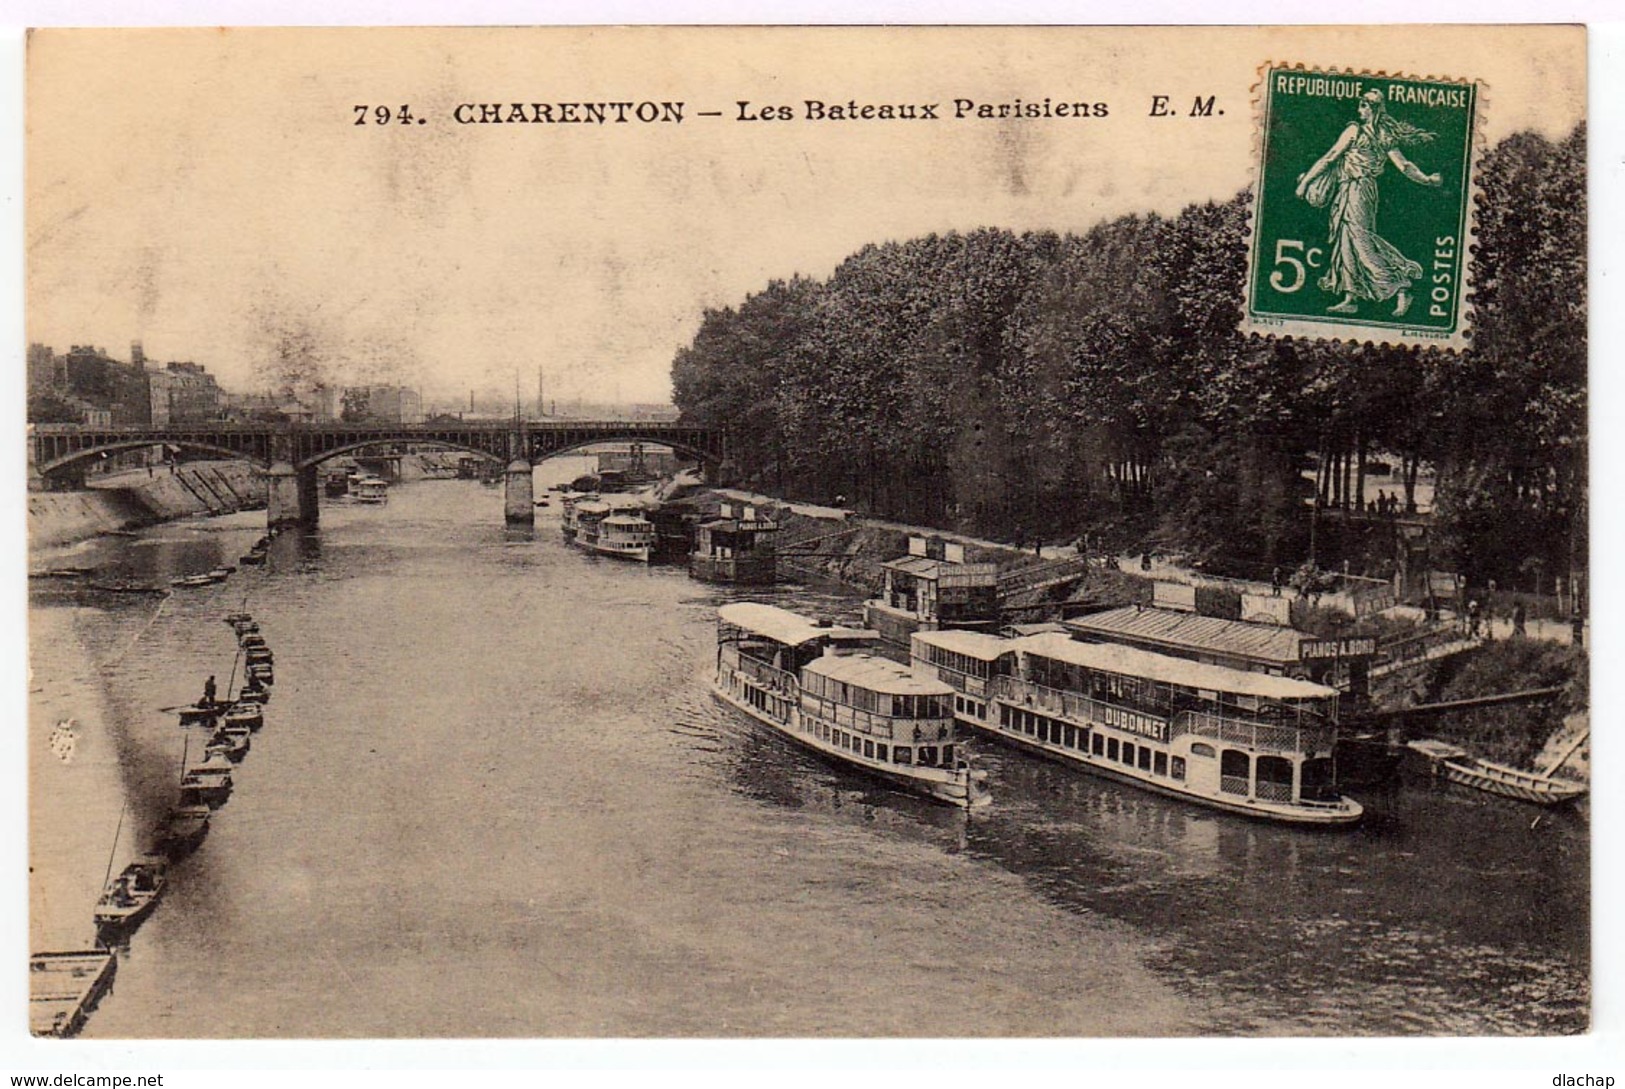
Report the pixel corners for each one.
[713,601,990,808]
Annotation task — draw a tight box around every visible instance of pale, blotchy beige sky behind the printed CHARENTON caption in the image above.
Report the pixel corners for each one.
[24,28,1584,403]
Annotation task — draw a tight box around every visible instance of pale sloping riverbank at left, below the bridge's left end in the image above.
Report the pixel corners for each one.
[28,462,265,553]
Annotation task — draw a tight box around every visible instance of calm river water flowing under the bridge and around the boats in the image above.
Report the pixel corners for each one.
[29,474,1589,1037]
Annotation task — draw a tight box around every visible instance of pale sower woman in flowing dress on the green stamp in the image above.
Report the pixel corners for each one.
[1295,91,1441,317]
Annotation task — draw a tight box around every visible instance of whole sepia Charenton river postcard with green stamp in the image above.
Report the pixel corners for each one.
[13,26,1594,1048]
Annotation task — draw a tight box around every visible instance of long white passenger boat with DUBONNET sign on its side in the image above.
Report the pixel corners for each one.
[910,631,1362,826]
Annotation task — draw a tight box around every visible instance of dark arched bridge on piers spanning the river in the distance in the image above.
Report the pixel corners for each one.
[29,419,726,525]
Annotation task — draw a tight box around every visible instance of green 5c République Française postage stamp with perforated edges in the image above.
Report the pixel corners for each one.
[1242,65,1482,349]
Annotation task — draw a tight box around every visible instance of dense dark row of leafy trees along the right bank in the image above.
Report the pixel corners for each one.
[673,128,1586,585]
